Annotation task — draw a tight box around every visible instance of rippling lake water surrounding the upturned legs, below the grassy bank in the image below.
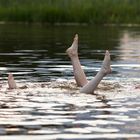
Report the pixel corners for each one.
[0,24,140,140]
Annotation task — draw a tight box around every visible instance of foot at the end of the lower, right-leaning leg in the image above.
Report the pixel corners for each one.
[101,50,111,74]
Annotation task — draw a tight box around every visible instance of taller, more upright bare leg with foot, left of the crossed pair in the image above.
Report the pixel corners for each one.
[66,34,88,86]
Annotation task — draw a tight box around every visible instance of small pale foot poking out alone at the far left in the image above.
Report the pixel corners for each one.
[8,73,17,89]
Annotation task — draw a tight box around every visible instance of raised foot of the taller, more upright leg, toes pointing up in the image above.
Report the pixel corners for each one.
[66,34,78,57]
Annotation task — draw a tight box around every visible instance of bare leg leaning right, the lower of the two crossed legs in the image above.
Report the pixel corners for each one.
[80,51,111,94]
